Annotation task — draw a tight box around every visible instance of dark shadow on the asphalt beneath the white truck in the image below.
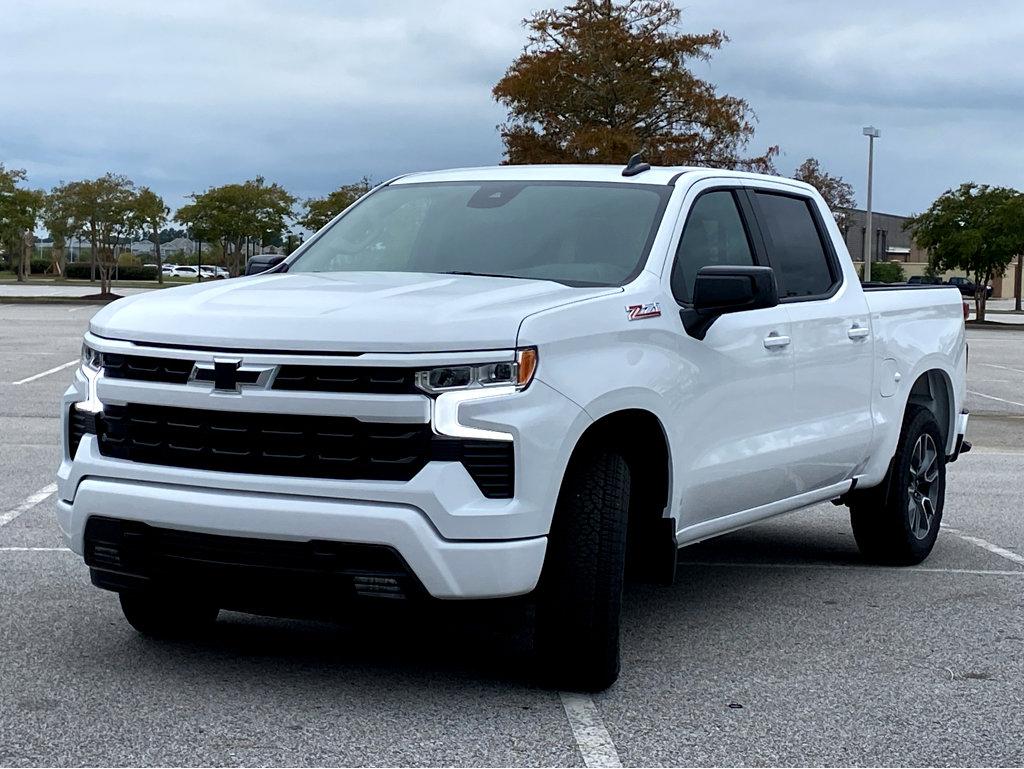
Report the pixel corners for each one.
[125,524,864,688]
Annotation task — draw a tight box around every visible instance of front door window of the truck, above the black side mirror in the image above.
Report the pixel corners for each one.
[672,189,754,302]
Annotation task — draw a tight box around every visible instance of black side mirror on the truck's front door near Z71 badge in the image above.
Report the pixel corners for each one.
[679,265,778,339]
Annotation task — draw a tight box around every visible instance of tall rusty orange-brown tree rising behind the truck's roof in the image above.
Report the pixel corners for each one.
[493,0,778,171]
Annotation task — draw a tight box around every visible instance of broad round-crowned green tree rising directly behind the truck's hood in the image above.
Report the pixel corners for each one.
[174,176,295,274]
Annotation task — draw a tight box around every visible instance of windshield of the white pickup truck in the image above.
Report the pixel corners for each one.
[288,181,672,286]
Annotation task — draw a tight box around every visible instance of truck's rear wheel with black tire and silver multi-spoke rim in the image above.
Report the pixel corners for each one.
[850,405,946,566]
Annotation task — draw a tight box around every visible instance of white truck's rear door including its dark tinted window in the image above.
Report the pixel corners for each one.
[749,188,873,494]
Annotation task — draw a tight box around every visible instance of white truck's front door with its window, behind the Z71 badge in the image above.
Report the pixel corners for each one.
[672,185,796,527]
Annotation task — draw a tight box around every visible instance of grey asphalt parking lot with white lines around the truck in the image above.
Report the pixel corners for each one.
[0,304,1024,766]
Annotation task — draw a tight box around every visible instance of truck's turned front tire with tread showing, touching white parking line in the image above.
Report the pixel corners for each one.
[537,451,630,691]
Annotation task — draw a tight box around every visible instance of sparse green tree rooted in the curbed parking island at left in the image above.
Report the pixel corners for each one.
[67,173,137,296]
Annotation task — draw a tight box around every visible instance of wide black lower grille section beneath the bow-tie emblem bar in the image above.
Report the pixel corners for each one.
[92,403,515,499]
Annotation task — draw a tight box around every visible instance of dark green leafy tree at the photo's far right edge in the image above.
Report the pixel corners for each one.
[905,182,1024,321]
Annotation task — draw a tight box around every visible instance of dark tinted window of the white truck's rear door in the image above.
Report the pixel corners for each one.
[757,193,834,297]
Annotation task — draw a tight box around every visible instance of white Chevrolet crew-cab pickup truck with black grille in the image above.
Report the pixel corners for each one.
[57,164,970,689]
